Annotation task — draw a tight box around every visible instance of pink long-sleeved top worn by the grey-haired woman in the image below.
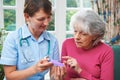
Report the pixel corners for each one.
[62,38,114,80]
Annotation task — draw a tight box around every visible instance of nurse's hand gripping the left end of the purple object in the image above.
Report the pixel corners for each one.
[34,58,53,73]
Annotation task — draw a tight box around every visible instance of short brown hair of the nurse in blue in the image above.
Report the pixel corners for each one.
[24,0,52,17]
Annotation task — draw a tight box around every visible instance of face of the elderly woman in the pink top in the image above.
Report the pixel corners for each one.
[74,27,94,49]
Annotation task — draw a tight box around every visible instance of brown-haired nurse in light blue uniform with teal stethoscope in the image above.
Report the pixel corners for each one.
[0,0,65,80]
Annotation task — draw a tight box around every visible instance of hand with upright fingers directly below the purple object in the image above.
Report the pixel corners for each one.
[50,66,66,80]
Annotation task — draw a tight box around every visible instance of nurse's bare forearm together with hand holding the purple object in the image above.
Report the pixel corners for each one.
[4,59,53,80]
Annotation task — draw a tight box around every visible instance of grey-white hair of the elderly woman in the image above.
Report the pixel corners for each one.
[70,9,105,46]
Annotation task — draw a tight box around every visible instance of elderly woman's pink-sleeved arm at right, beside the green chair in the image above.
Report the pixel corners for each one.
[101,49,114,80]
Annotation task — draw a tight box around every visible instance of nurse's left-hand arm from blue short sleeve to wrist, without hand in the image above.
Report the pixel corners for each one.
[0,33,35,80]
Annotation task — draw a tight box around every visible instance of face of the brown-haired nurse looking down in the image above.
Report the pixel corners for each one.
[26,9,51,33]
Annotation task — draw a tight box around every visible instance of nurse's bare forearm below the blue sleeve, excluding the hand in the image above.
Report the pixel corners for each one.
[4,65,36,80]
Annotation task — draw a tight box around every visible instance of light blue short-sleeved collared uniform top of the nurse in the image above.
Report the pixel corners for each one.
[0,25,59,80]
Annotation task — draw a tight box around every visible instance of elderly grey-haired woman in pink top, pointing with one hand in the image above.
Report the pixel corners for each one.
[62,10,114,80]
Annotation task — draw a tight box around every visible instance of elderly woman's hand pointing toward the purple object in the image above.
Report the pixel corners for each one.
[62,56,82,73]
